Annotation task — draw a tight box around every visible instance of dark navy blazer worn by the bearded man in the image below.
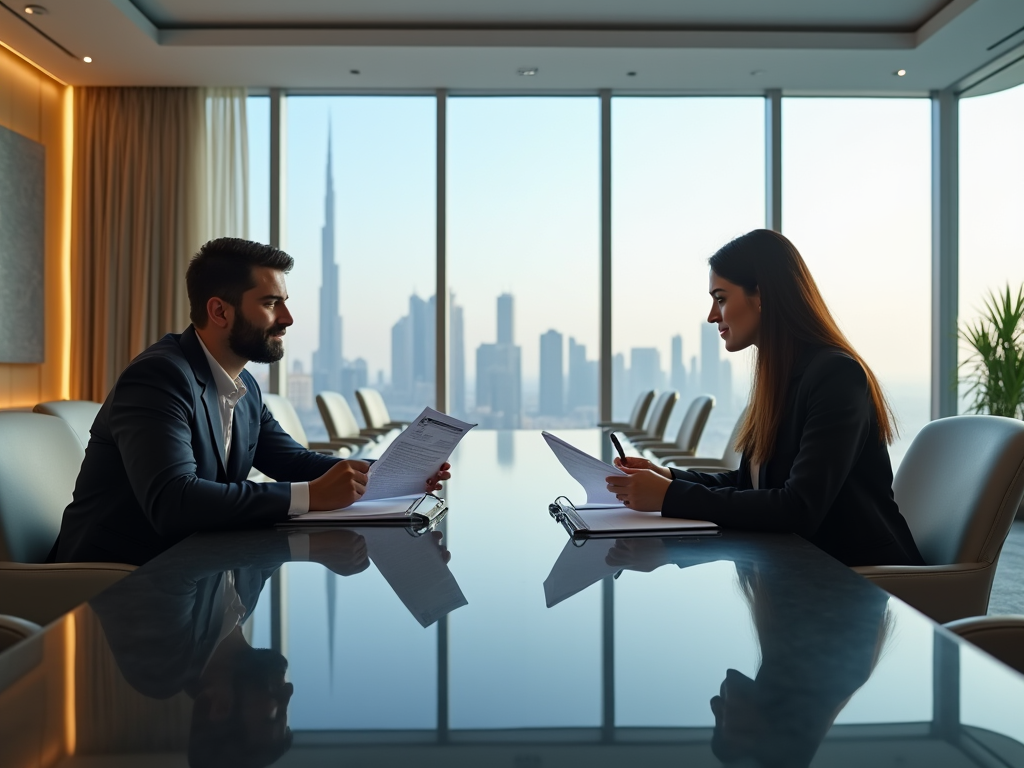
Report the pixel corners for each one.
[50,326,339,565]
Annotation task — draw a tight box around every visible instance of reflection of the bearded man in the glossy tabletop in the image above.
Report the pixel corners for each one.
[90,529,376,768]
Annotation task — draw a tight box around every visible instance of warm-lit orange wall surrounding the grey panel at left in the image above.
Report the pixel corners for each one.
[0,47,72,409]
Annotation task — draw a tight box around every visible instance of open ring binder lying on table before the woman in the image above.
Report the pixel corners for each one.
[548,496,719,544]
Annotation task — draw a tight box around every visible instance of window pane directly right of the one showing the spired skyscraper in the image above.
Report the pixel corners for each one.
[447,97,601,429]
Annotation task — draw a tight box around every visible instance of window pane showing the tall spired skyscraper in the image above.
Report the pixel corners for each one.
[284,96,436,440]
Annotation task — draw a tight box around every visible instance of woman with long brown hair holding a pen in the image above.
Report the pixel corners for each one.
[608,229,924,565]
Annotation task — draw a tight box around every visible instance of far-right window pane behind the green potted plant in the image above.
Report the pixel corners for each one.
[958,85,1024,413]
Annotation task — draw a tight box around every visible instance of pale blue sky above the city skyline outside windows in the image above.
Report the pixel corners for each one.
[249,86,1024,456]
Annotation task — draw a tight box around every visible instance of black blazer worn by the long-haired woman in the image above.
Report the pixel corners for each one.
[662,347,924,565]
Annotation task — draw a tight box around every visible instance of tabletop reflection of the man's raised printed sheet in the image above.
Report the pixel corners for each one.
[359,528,469,627]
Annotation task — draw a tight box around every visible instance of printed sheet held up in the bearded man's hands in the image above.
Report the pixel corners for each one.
[361,408,476,501]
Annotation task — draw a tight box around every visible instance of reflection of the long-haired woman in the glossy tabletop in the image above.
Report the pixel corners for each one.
[711,562,891,768]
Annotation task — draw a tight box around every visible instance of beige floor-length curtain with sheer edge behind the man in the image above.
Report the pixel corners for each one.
[71,88,248,401]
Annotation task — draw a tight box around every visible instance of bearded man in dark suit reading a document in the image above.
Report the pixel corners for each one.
[51,238,450,565]
